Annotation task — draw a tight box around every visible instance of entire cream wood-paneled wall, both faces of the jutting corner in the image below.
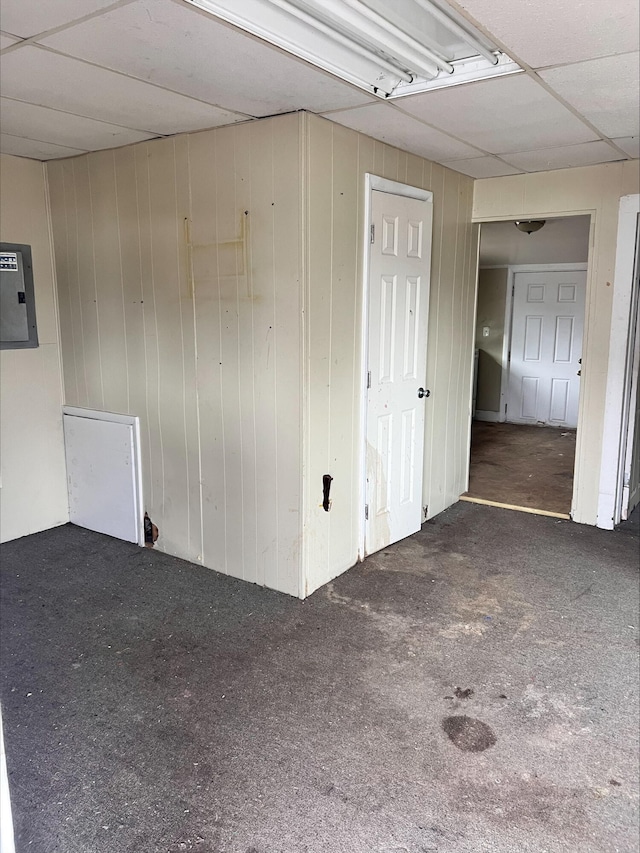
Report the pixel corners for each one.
[49,114,477,596]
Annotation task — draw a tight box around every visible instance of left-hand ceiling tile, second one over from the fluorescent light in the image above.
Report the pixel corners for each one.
[0,47,247,134]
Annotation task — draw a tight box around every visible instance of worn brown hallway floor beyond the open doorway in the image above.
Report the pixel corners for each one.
[467,421,576,516]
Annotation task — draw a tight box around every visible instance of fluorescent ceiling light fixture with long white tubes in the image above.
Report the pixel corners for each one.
[185,0,522,98]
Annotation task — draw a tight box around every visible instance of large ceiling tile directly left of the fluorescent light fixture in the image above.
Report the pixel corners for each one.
[43,0,370,116]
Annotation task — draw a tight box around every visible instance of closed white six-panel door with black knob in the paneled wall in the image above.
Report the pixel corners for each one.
[365,191,433,554]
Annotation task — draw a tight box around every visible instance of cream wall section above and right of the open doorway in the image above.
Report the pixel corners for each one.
[473,156,639,524]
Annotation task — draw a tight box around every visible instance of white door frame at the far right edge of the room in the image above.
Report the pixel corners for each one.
[597,194,640,530]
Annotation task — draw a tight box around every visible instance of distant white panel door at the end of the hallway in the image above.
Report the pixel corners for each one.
[506,270,587,427]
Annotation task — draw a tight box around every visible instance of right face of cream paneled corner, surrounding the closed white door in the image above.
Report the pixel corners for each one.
[304,115,478,592]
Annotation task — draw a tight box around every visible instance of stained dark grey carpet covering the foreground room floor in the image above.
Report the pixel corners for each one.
[0,503,639,853]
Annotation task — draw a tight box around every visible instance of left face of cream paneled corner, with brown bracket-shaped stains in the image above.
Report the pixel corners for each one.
[48,115,302,595]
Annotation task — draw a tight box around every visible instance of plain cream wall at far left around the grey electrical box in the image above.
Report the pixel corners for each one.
[0,155,69,542]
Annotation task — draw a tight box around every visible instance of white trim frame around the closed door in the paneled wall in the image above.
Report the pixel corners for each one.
[358,172,433,561]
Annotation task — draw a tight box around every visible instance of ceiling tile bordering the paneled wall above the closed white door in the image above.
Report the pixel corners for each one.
[326,103,478,162]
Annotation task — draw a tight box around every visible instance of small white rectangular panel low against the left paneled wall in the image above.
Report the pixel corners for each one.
[63,407,144,545]
